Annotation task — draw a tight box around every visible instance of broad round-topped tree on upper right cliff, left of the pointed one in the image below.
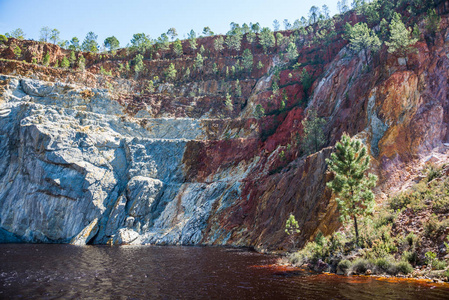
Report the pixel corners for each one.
[345,23,381,62]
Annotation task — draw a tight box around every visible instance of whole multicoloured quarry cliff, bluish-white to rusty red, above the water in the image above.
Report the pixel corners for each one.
[0,3,449,249]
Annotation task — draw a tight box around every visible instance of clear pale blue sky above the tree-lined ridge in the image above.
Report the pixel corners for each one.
[0,0,337,46]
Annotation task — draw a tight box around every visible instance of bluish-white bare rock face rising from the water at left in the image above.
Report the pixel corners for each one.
[0,75,245,245]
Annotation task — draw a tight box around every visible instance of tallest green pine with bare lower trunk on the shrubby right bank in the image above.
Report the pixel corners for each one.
[326,134,377,243]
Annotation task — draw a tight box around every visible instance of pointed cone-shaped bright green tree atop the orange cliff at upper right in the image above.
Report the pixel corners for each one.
[385,13,418,56]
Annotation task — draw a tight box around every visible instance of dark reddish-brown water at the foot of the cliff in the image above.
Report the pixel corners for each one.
[0,245,449,299]
